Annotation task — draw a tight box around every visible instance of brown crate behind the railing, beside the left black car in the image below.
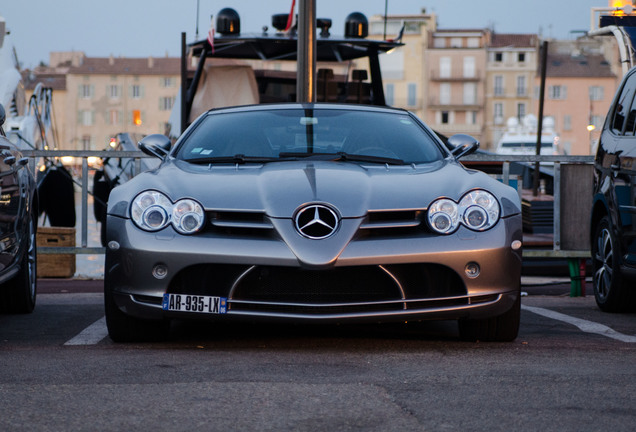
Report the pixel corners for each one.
[36,227,75,278]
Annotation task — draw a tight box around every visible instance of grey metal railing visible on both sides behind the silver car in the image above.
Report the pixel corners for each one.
[23,150,594,258]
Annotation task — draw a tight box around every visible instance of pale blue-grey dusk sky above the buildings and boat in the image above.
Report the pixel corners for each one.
[0,0,608,68]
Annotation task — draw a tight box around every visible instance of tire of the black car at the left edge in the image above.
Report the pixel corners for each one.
[0,214,38,314]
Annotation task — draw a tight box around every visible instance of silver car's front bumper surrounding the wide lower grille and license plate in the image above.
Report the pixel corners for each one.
[105,216,521,322]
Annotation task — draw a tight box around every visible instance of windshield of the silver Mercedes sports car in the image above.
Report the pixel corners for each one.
[176,109,444,163]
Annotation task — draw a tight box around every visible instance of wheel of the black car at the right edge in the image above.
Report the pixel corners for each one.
[592,216,636,312]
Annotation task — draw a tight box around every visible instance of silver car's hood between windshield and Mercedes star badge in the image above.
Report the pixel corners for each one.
[109,160,520,218]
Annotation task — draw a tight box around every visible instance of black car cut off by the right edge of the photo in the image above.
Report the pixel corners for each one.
[590,68,636,312]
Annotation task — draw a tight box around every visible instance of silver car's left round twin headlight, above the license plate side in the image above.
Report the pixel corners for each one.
[130,191,205,234]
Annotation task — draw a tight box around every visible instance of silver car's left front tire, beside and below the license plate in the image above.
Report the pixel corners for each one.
[104,289,170,342]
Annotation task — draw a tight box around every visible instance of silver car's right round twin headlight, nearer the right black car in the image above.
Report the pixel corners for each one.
[428,190,499,234]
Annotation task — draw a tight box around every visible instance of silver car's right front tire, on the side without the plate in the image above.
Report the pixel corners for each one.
[459,295,521,342]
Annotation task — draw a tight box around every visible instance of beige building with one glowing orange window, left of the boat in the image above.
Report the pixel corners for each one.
[25,52,181,150]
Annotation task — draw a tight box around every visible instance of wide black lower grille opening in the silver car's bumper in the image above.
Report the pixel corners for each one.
[169,264,469,315]
